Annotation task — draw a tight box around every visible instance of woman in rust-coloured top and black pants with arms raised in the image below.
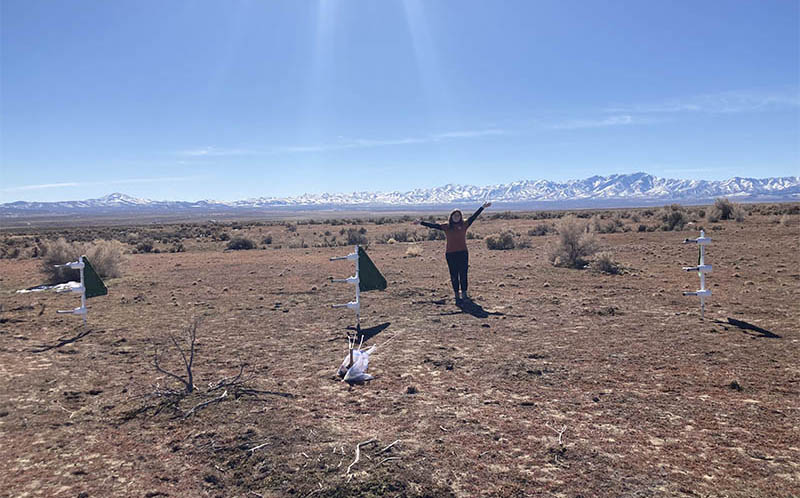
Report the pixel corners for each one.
[414,202,492,304]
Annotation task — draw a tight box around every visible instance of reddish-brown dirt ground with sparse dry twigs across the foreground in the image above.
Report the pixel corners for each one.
[0,212,800,497]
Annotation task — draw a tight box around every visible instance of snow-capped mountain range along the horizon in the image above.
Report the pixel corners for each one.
[0,173,800,217]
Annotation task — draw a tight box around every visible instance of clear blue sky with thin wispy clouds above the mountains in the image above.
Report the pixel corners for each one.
[0,0,800,202]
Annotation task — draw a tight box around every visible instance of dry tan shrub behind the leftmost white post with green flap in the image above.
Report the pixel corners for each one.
[41,238,123,284]
